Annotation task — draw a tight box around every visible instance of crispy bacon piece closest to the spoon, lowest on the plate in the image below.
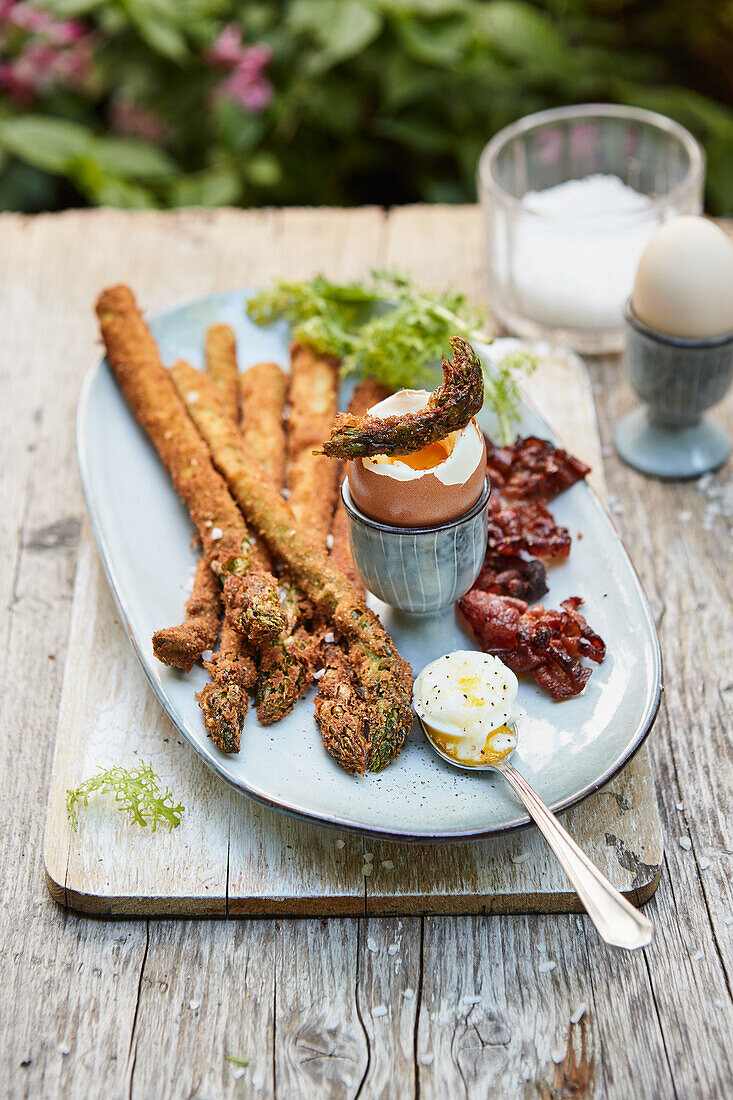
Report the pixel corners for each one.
[460,589,605,700]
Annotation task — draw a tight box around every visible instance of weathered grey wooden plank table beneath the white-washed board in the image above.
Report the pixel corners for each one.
[0,207,733,1100]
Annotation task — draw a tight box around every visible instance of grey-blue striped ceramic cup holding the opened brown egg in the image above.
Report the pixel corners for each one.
[341,479,491,615]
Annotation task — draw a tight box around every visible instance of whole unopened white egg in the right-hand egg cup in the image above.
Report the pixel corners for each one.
[632,216,733,339]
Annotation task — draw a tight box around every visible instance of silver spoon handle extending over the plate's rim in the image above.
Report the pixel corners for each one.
[496,763,654,950]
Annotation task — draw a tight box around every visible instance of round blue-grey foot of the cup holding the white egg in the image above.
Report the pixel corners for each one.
[614,407,731,480]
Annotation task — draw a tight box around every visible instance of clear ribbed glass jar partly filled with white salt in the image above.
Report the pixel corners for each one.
[479,105,704,353]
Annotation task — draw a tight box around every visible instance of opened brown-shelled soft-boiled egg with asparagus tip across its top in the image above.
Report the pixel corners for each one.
[348,389,486,527]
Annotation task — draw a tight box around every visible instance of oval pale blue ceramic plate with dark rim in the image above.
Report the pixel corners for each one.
[77,290,661,840]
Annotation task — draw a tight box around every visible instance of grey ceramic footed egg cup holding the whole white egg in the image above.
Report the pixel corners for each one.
[614,301,733,479]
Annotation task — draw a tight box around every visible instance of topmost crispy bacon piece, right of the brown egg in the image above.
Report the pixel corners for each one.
[486,436,590,501]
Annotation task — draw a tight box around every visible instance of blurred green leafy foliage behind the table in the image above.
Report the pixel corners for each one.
[0,0,733,213]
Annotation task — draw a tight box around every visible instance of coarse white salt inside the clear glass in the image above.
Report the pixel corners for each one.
[492,174,658,329]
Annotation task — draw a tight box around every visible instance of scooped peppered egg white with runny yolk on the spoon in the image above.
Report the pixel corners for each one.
[413,650,518,765]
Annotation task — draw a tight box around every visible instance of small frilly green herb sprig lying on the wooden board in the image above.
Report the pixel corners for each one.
[66,762,184,833]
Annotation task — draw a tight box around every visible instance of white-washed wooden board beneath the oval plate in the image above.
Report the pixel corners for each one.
[44,353,663,916]
